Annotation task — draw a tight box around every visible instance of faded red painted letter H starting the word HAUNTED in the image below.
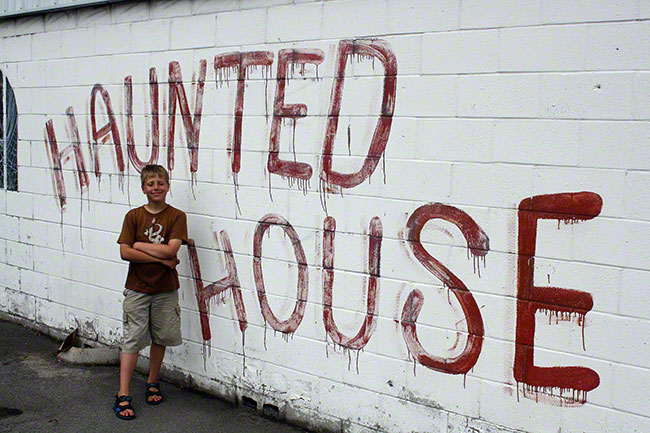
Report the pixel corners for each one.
[45,107,90,209]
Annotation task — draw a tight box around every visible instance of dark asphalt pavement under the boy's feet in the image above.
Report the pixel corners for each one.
[0,320,304,433]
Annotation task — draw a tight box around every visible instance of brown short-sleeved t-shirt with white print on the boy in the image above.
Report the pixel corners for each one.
[117,205,187,295]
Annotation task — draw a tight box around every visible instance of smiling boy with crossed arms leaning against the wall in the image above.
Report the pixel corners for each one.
[113,164,187,420]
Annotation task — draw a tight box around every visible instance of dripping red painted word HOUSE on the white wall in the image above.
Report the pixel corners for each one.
[188,192,602,404]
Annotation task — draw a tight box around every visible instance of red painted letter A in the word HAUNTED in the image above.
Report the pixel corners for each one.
[90,84,126,178]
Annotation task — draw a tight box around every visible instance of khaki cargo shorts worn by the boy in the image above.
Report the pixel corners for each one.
[122,289,183,353]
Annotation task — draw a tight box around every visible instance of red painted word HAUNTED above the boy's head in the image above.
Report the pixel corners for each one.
[45,39,397,209]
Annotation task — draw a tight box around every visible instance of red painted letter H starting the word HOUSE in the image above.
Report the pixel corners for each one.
[187,230,248,341]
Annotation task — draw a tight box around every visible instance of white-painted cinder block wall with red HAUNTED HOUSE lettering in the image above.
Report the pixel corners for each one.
[0,0,650,433]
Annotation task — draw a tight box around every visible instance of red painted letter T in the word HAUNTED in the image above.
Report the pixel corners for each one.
[214,51,273,173]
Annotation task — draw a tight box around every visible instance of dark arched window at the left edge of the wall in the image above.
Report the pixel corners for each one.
[0,71,18,191]
